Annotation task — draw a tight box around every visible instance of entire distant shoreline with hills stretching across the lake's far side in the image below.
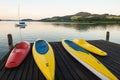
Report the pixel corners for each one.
[0,12,120,24]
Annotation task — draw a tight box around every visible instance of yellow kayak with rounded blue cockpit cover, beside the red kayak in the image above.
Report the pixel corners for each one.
[32,39,55,80]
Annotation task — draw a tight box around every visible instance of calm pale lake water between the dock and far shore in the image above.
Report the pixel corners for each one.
[0,21,120,58]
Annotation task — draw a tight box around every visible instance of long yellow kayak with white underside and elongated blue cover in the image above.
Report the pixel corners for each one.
[62,39,118,80]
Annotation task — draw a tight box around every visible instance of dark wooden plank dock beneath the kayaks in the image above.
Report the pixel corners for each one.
[0,40,120,80]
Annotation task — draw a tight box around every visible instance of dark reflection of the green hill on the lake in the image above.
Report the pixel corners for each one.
[51,22,120,32]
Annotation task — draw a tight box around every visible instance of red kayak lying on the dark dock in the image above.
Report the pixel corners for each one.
[5,41,30,68]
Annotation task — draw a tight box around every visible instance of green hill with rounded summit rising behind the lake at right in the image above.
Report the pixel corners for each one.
[39,12,120,23]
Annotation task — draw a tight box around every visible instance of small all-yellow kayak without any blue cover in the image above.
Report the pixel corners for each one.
[73,39,107,56]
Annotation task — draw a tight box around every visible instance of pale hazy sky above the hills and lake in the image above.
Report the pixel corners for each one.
[0,0,120,19]
